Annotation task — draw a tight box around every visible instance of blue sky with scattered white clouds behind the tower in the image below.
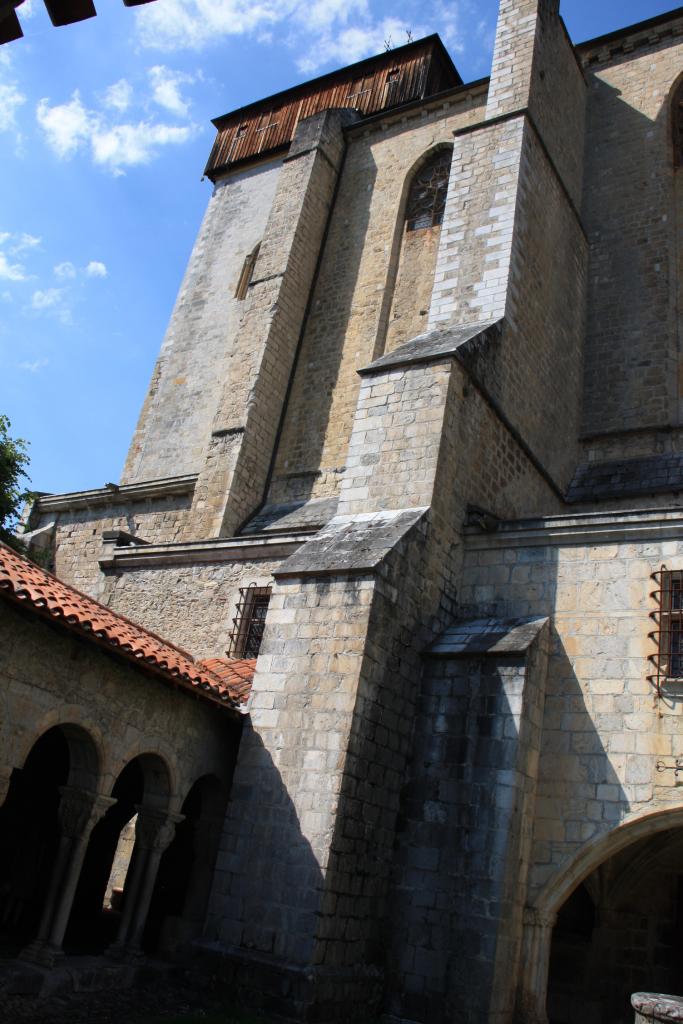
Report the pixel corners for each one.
[0,0,677,492]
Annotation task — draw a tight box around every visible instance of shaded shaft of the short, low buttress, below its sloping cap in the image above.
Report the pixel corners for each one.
[386,630,546,1022]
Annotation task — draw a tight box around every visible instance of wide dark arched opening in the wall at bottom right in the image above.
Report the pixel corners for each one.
[548,828,683,1024]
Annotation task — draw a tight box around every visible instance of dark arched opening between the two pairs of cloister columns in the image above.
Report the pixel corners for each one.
[65,754,170,953]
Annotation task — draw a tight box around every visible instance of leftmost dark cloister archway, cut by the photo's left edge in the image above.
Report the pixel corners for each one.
[0,724,98,955]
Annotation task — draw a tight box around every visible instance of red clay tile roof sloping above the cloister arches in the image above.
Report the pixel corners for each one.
[0,543,256,711]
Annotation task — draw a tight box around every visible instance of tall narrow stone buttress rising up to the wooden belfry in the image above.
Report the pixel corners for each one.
[193,110,355,537]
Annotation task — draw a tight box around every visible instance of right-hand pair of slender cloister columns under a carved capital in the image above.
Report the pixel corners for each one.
[108,807,184,958]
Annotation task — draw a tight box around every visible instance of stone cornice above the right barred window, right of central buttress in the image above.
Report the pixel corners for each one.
[464,507,683,551]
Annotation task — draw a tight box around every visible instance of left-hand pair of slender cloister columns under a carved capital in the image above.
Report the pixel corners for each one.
[19,785,116,967]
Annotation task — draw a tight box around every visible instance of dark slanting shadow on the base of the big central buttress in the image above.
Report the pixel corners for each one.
[203,724,327,1019]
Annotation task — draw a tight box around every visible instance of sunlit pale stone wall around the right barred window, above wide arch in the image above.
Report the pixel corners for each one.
[461,513,683,902]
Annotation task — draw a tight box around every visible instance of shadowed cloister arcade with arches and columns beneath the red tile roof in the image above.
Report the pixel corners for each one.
[0,577,242,968]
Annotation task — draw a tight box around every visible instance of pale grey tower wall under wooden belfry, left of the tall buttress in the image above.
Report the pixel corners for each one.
[122,160,282,483]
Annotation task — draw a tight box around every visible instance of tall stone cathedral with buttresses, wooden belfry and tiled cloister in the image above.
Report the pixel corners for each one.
[0,0,683,1024]
